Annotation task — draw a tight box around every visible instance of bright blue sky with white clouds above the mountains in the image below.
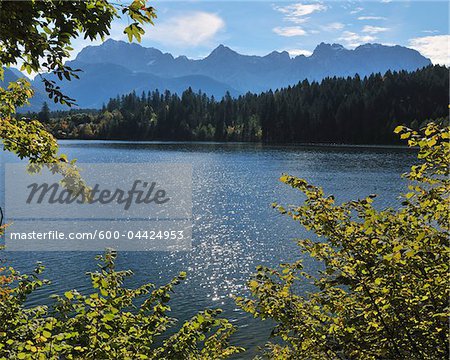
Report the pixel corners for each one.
[74,0,450,65]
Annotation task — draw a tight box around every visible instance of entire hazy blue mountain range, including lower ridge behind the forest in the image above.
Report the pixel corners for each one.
[5,39,431,108]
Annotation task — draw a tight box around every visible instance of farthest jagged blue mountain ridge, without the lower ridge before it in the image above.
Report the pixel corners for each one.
[75,40,431,93]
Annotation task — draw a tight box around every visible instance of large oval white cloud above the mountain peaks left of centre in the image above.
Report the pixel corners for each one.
[145,11,225,47]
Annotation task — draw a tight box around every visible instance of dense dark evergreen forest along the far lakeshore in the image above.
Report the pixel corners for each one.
[34,66,449,144]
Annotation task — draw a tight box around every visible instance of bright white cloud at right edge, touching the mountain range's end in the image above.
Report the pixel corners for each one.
[409,35,450,65]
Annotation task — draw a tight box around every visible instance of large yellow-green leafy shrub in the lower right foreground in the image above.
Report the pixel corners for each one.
[238,124,450,359]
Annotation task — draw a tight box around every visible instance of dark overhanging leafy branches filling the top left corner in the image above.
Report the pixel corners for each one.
[0,0,156,105]
